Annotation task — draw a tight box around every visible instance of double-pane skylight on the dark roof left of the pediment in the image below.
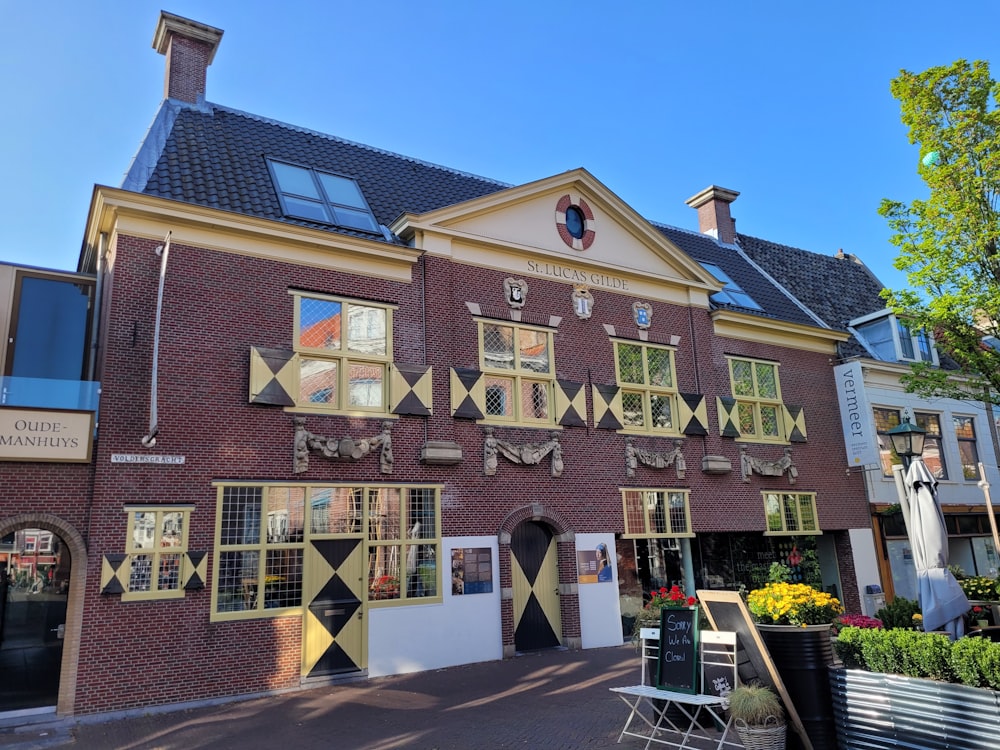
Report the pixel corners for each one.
[268,160,380,233]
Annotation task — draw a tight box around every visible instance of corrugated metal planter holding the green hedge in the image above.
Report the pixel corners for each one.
[830,668,1000,750]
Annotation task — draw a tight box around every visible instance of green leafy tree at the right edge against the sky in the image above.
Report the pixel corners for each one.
[879,60,1000,403]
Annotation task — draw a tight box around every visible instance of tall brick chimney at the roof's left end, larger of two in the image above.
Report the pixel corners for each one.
[153,10,222,104]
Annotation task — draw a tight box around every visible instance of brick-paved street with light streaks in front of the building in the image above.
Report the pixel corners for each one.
[0,646,748,750]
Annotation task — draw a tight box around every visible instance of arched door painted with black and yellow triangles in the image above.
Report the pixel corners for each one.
[510,520,562,651]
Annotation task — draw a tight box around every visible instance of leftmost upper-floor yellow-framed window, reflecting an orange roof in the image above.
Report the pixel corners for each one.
[292,292,393,414]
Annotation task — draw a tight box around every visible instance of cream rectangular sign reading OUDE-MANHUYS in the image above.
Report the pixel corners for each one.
[0,407,94,463]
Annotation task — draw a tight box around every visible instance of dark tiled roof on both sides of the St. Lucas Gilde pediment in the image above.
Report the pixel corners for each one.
[126,101,817,325]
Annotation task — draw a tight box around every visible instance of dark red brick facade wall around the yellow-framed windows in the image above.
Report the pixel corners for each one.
[0,231,868,713]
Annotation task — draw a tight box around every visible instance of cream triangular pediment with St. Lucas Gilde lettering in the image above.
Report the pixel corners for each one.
[392,169,719,306]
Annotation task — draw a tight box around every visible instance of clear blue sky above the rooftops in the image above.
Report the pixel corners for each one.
[0,0,1000,294]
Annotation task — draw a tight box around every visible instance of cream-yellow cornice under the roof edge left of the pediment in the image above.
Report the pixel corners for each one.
[84,185,422,282]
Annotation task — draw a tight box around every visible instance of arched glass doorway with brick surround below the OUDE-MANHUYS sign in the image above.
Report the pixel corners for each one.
[0,514,87,714]
